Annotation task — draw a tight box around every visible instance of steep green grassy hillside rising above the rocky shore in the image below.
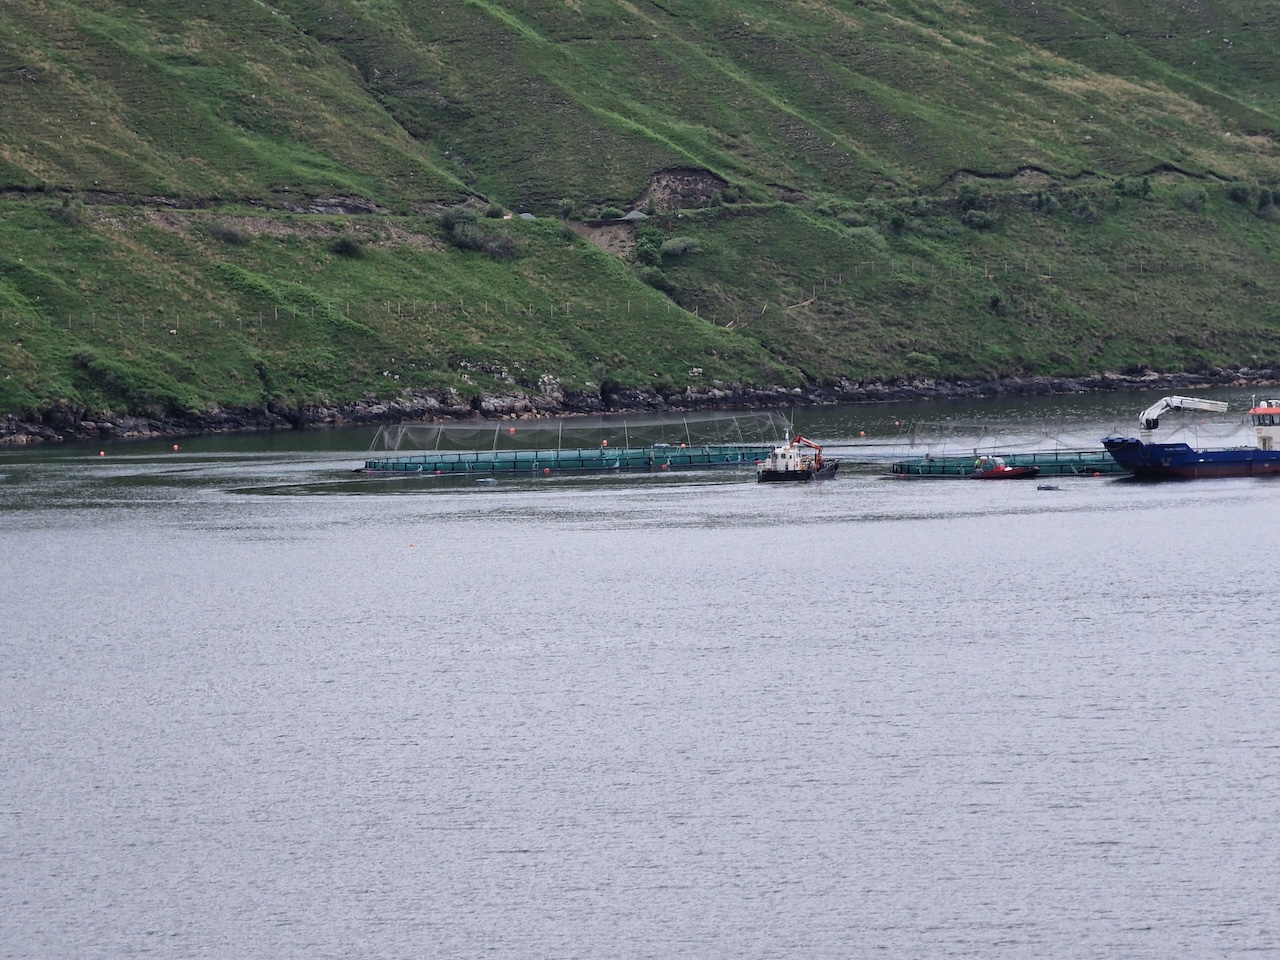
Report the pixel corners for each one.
[0,0,1280,416]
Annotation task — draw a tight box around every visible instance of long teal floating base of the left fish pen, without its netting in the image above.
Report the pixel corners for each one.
[365,443,773,476]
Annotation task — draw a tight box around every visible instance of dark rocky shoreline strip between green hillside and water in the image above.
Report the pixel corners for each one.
[0,367,1280,445]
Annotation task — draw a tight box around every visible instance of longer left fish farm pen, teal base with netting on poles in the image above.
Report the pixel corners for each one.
[364,412,791,476]
